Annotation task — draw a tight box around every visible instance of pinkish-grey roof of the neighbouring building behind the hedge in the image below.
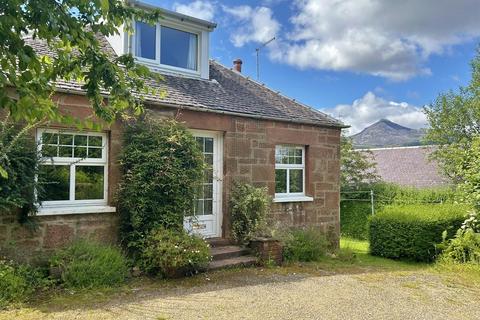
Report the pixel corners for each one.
[370,146,449,188]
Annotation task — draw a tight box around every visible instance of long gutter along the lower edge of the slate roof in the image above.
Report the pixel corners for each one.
[55,88,350,129]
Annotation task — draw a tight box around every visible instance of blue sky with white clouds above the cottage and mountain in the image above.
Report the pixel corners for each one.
[144,0,480,134]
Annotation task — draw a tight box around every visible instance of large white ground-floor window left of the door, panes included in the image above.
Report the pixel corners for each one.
[37,129,108,213]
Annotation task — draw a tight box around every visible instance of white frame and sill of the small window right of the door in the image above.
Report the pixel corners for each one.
[273,144,313,202]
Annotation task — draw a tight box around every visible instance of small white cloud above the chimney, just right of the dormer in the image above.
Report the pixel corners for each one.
[223,6,280,47]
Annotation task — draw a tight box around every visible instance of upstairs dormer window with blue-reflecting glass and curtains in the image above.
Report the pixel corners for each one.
[133,21,200,72]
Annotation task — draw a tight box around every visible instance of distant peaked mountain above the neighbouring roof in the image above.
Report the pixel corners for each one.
[351,119,425,148]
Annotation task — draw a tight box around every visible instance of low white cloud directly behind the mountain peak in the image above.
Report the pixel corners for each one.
[325,92,427,134]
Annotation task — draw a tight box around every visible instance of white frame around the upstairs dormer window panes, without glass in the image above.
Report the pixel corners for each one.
[130,20,203,77]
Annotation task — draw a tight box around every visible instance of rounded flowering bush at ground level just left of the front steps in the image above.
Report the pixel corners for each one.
[138,228,211,278]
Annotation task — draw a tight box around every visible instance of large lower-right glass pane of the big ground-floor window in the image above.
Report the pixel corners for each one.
[75,166,104,200]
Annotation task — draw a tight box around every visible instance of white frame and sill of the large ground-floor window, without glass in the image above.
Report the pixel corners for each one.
[36,128,110,215]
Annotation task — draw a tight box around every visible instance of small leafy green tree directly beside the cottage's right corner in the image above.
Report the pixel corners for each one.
[340,136,378,189]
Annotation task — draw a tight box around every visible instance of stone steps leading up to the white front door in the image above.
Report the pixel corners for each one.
[208,238,258,271]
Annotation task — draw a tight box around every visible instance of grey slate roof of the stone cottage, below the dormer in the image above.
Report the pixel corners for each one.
[26,37,346,128]
